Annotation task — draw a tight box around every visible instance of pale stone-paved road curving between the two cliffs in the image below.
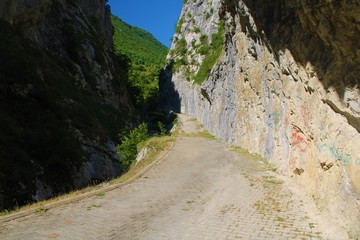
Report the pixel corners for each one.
[0,115,348,240]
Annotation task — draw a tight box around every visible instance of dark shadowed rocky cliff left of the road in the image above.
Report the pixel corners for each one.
[0,0,136,209]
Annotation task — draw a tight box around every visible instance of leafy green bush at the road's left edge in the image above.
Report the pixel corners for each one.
[116,123,149,171]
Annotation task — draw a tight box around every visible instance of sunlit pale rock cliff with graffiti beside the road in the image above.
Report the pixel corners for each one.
[161,0,360,236]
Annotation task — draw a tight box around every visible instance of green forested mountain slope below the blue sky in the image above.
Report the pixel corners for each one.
[111,16,168,111]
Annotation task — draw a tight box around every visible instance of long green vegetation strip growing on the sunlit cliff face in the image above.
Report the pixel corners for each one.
[194,22,224,85]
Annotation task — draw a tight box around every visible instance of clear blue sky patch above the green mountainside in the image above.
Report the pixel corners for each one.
[109,0,184,47]
